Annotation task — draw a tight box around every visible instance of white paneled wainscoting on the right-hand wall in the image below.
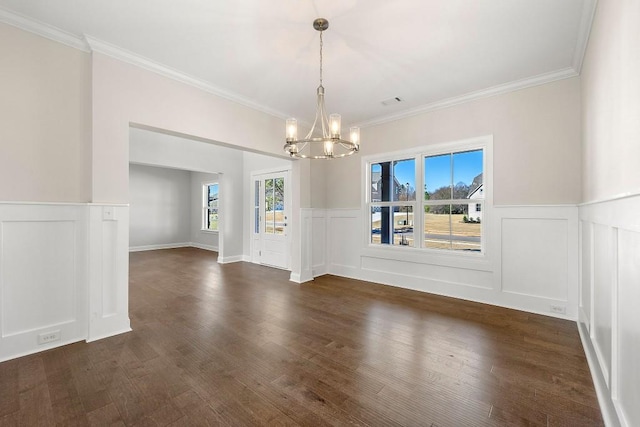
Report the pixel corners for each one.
[578,195,640,427]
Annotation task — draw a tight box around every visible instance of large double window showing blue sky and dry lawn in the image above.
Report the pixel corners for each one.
[366,138,489,252]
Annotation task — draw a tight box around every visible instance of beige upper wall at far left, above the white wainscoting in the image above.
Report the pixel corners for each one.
[0,23,91,202]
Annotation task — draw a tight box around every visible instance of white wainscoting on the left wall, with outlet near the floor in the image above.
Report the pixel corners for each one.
[0,202,130,361]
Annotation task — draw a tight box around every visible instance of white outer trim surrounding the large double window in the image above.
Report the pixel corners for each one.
[361,135,493,270]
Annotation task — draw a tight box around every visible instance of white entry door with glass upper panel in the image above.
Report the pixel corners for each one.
[252,171,290,269]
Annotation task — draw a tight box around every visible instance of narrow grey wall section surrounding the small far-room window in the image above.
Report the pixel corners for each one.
[189,172,220,251]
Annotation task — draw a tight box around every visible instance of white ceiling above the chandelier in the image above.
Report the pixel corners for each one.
[0,0,595,124]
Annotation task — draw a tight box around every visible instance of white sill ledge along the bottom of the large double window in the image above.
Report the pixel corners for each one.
[361,245,494,271]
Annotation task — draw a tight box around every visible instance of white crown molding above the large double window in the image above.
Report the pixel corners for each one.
[352,67,578,128]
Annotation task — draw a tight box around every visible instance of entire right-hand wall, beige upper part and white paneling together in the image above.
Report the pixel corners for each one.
[579,0,640,426]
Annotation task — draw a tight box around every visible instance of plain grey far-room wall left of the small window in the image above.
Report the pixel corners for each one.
[129,164,191,249]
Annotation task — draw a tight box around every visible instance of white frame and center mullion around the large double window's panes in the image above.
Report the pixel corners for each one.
[361,135,493,265]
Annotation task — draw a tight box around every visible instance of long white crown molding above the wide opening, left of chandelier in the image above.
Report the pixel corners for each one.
[84,34,289,119]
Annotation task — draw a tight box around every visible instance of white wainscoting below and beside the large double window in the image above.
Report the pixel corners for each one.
[310,205,579,320]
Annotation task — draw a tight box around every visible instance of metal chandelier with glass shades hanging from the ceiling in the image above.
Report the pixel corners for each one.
[284,18,360,159]
